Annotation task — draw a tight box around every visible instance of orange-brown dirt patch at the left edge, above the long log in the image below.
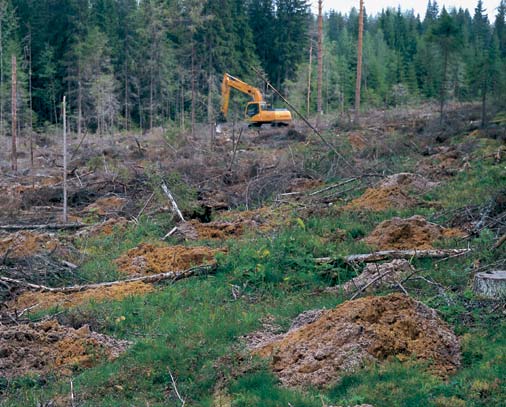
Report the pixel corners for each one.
[0,231,58,259]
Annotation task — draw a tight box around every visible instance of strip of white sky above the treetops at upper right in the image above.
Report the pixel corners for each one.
[311,0,500,21]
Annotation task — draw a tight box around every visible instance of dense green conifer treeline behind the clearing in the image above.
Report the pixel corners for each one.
[0,0,506,134]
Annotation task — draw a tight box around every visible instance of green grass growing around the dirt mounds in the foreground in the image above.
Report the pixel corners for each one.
[0,134,506,407]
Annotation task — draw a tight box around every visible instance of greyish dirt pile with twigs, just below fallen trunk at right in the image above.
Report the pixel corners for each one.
[326,259,414,294]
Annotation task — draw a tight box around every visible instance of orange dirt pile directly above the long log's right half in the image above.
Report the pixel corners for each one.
[116,243,223,276]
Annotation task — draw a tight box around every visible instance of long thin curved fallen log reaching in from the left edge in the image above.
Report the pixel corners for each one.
[0,264,216,294]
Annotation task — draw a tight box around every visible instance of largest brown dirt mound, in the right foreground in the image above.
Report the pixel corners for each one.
[253,294,460,387]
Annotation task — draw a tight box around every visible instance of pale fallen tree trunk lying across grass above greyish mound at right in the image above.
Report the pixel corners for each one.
[315,249,471,264]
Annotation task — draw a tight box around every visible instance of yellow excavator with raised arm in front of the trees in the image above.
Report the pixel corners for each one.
[219,73,292,127]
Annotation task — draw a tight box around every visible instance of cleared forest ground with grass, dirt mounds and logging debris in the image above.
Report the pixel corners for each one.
[0,104,506,407]
